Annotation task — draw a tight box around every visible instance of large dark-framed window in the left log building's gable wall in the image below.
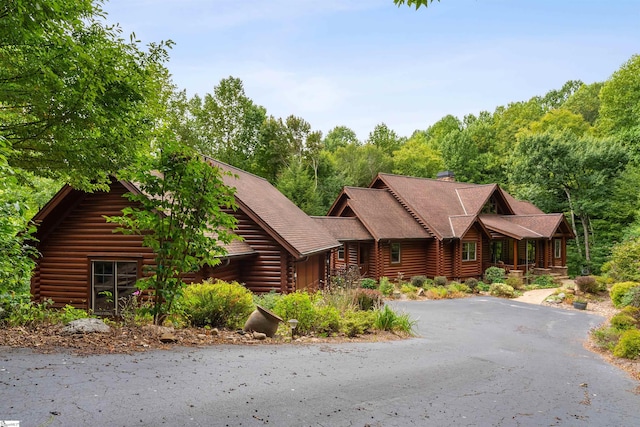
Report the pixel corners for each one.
[91,261,138,316]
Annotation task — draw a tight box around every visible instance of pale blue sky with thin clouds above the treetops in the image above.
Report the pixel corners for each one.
[104,0,640,140]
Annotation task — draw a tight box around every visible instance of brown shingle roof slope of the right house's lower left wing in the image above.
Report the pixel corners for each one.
[343,187,432,240]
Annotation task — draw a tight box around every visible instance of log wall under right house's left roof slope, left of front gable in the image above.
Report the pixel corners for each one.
[380,241,427,280]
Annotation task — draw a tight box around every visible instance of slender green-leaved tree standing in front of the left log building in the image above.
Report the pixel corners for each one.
[105,140,236,324]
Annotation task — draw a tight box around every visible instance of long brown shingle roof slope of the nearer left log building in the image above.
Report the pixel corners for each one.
[208,159,340,258]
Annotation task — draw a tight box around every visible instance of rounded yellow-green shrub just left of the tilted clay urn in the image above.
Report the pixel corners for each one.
[180,281,254,329]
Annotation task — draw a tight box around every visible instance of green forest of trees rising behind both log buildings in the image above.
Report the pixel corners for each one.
[0,0,640,294]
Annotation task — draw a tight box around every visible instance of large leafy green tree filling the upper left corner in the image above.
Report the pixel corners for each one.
[0,0,171,189]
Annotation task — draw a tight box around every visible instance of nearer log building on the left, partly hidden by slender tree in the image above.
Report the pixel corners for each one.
[31,159,340,315]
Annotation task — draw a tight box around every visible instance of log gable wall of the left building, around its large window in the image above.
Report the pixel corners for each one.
[32,183,154,309]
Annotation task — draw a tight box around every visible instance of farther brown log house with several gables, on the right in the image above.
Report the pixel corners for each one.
[314,173,574,280]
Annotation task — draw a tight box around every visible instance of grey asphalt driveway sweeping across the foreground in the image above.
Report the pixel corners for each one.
[0,297,640,427]
